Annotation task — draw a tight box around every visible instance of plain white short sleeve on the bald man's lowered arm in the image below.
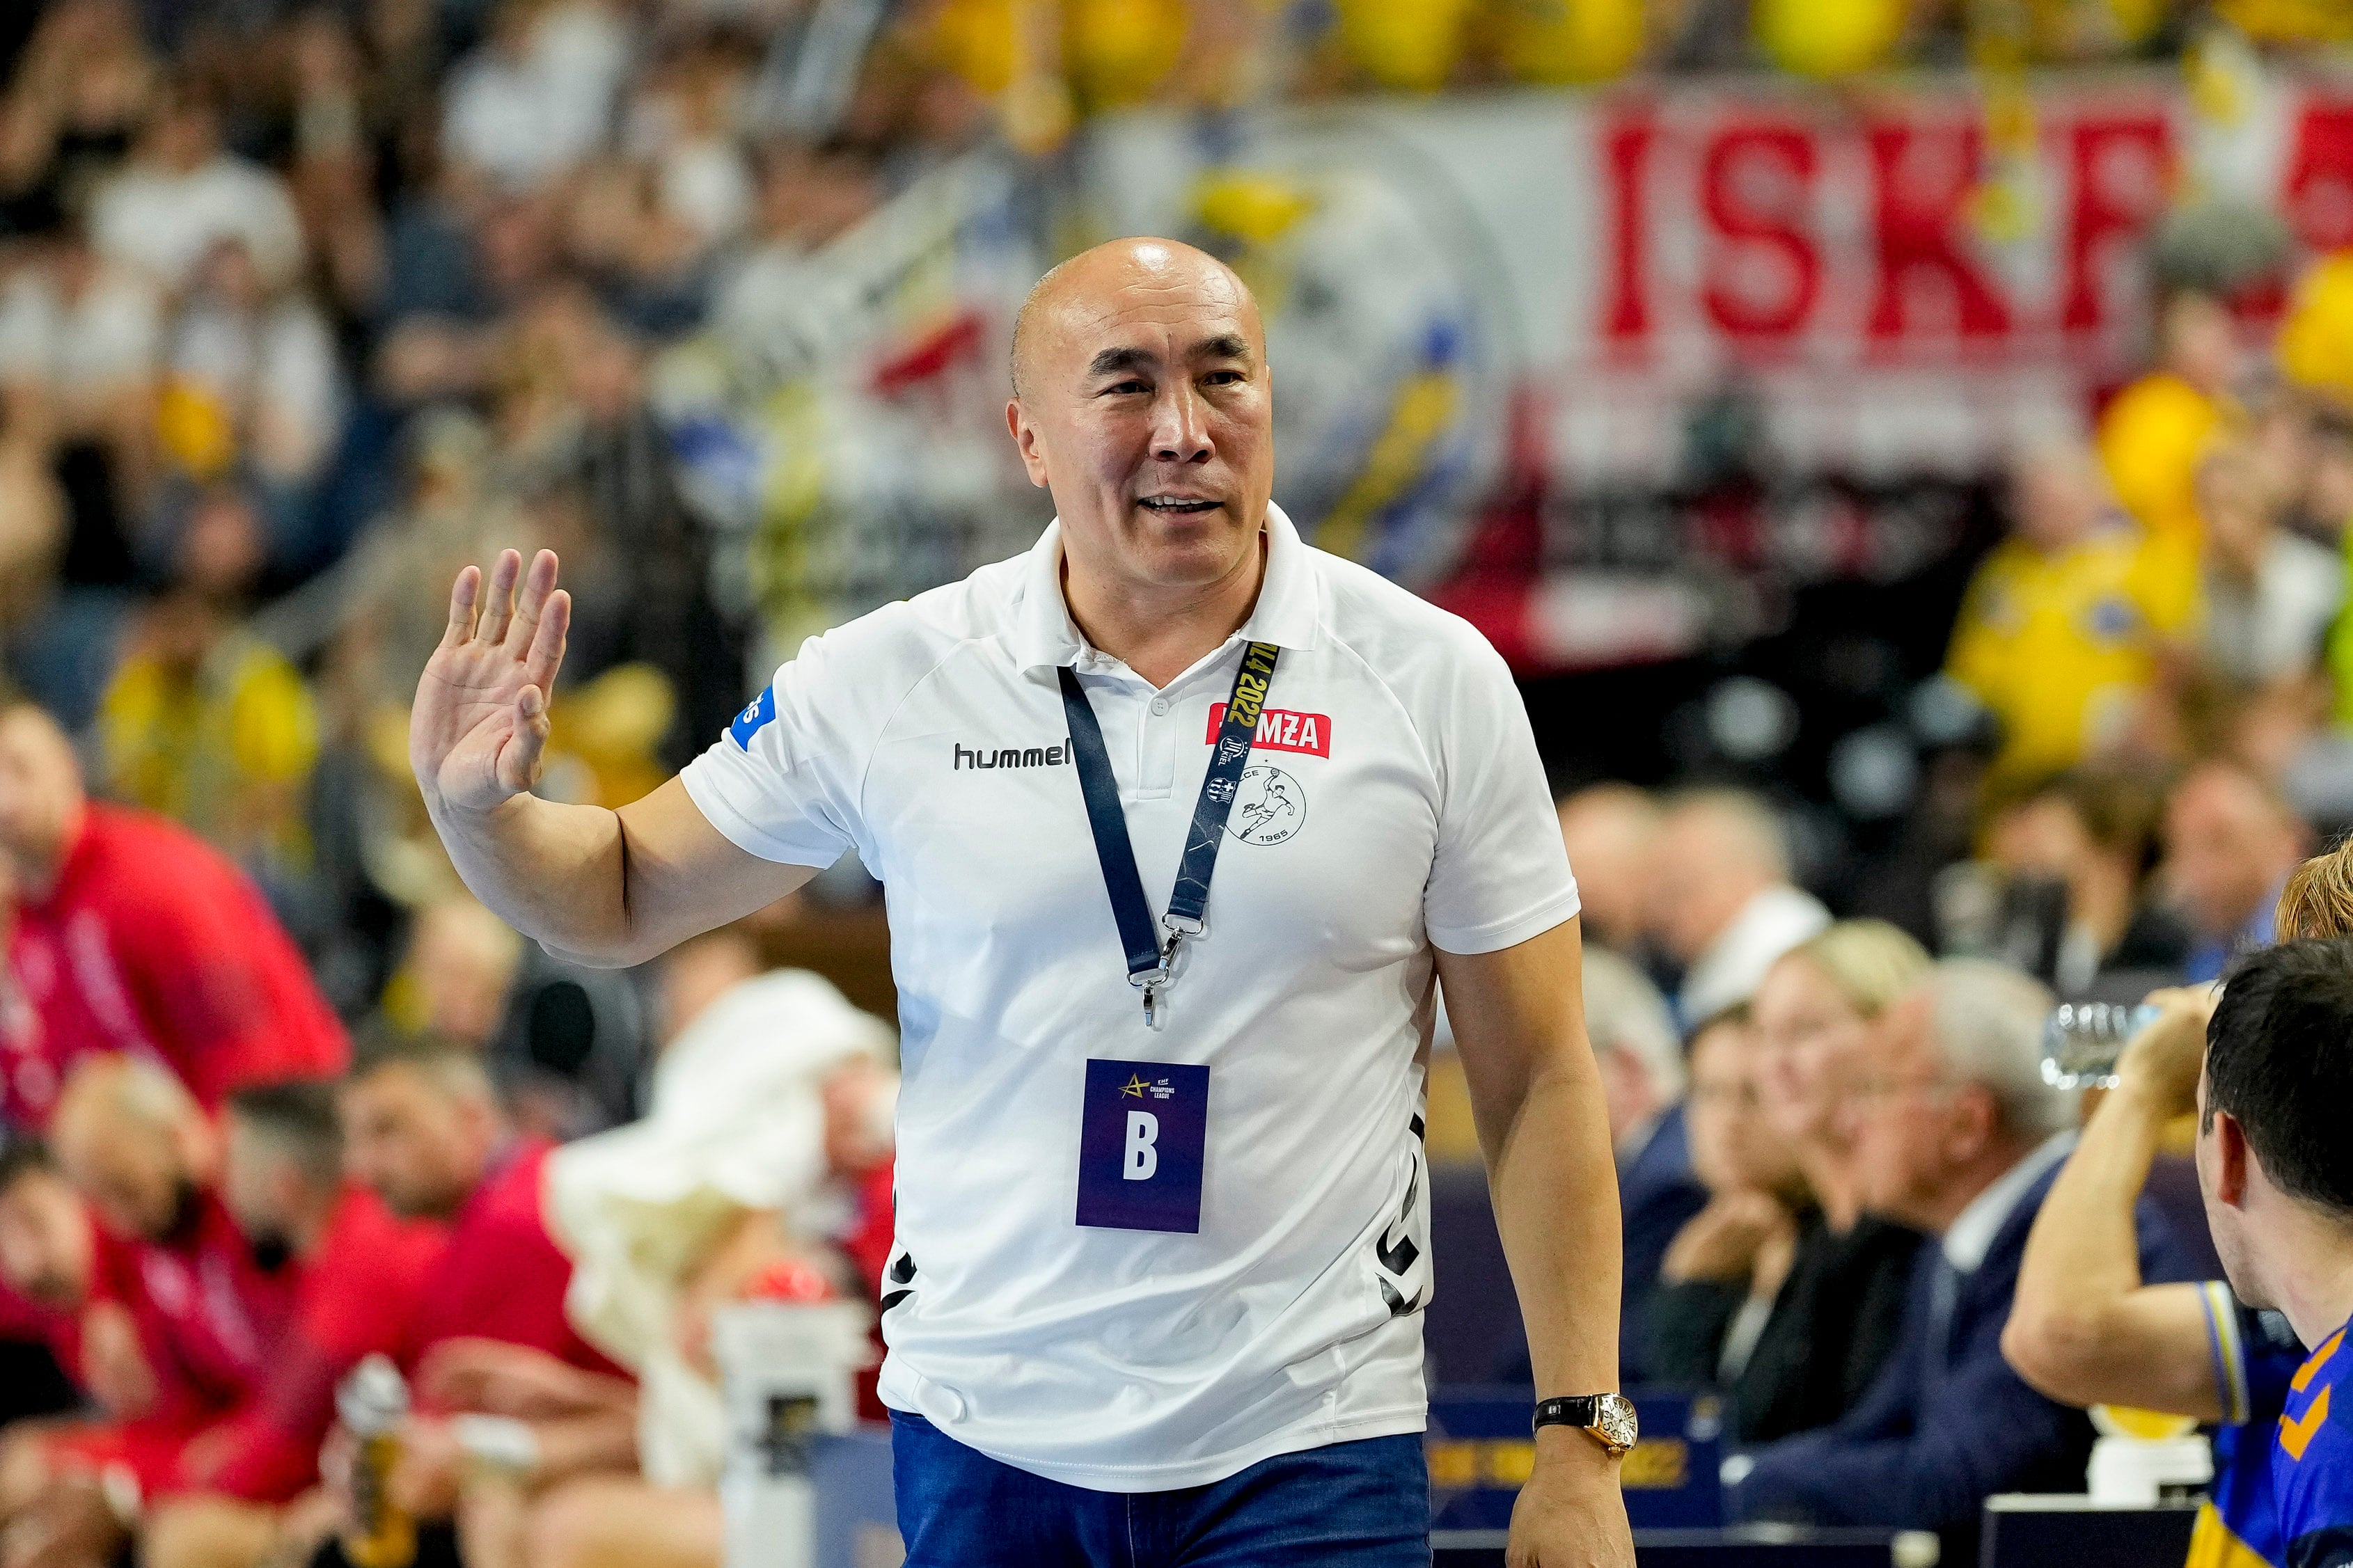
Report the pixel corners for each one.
[1422,633,1579,952]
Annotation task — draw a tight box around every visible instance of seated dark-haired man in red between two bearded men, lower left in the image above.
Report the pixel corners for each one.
[141,1082,442,1568]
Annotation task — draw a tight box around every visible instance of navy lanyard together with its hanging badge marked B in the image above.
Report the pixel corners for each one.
[1057,642,1280,1234]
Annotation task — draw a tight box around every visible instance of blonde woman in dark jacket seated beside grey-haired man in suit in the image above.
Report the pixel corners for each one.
[1654,919,1930,1443]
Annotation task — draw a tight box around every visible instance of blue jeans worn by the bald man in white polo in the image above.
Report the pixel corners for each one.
[890,1411,1431,1568]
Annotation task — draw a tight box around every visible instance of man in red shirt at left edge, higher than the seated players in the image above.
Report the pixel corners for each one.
[0,703,351,1128]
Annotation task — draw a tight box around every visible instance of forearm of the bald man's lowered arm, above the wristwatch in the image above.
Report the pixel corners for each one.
[1487,1067,1623,1399]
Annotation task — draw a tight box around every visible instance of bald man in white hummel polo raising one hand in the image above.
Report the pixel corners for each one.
[409,240,1633,1568]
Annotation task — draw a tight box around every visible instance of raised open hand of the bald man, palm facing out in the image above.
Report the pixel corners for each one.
[409,550,572,811]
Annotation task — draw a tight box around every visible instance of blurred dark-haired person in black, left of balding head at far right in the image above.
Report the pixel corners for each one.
[1986,766,2191,997]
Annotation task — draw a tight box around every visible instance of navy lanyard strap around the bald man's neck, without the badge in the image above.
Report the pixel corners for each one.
[1054,642,1282,1029]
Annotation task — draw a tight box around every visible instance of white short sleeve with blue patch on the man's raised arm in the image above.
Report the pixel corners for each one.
[680,633,873,865]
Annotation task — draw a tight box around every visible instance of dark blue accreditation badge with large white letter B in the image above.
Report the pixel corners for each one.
[1078,1060,1209,1234]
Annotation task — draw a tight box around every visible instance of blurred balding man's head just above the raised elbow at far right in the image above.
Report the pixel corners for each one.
[2165,761,2306,981]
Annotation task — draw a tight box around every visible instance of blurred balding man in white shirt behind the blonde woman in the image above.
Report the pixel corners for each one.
[1647,790,1831,1027]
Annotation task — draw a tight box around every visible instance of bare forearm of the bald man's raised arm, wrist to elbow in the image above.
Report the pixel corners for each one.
[426,795,628,964]
